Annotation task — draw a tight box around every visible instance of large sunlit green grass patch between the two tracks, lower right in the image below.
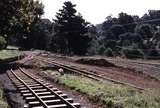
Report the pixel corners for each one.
[58,75,160,108]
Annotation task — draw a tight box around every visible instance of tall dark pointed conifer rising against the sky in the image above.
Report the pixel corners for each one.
[52,1,90,55]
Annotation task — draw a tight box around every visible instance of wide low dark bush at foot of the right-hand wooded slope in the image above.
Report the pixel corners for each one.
[122,49,144,59]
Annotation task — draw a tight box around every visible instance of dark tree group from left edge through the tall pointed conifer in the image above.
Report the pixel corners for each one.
[0,0,91,55]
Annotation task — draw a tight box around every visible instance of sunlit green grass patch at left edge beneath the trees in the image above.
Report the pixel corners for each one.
[0,49,22,60]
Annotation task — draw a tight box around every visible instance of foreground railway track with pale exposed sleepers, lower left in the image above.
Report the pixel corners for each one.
[8,68,81,108]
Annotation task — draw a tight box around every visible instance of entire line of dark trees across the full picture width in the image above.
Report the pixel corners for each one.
[0,0,160,59]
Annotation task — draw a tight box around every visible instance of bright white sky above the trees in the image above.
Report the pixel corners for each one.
[40,0,160,24]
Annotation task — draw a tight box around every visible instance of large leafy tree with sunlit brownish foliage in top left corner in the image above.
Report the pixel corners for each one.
[0,0,43,48]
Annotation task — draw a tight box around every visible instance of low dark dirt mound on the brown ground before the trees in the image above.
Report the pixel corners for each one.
[76,58,115,67]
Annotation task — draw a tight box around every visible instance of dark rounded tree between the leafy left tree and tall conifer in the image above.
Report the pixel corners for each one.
[29,19,52,50]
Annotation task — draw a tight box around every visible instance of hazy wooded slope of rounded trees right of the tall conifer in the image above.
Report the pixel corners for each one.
[91,10,160,59]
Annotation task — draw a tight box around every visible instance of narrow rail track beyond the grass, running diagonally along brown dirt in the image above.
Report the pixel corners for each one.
[34,56,146,90]
